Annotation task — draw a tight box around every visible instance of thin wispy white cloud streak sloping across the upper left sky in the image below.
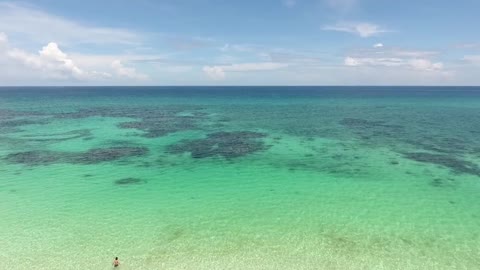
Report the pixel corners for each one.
[0,2,142,44]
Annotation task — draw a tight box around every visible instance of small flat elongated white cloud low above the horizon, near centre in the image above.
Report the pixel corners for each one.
[203,62,288,80]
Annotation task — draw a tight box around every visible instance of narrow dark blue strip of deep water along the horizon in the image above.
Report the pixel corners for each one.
[0,86,480,98]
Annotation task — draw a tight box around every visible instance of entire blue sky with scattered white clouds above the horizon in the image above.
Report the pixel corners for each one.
[0,0,480,86]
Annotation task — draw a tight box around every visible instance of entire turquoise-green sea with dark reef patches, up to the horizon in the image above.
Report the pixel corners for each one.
[0,87,480,269]
